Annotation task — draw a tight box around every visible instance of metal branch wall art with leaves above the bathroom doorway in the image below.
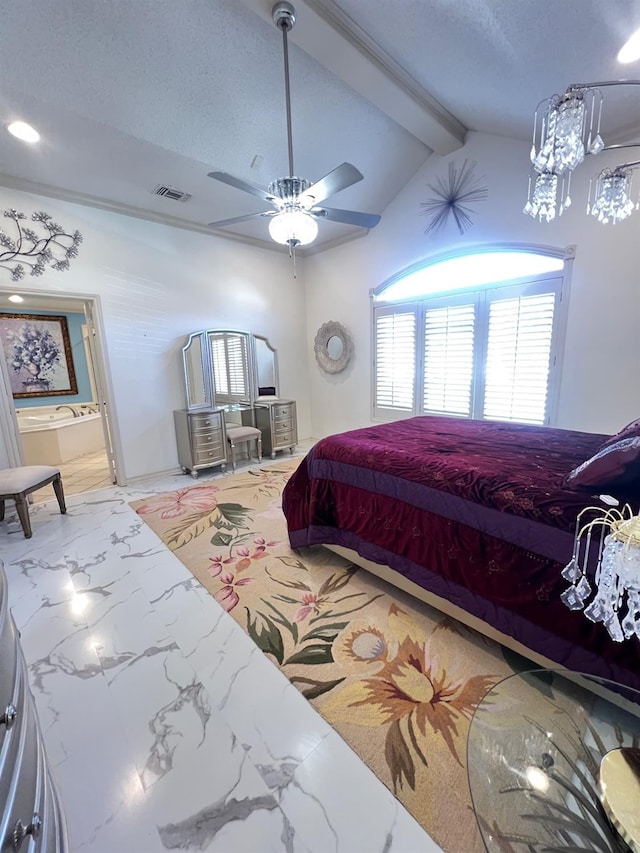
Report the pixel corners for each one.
[0,210,82,281]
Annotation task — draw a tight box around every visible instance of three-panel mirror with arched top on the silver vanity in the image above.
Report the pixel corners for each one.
[182,329,279,409]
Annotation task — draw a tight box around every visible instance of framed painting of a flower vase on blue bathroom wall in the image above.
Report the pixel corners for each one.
[0,314,78,399]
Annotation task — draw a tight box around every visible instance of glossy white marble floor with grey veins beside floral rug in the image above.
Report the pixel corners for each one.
[0,450,440,853]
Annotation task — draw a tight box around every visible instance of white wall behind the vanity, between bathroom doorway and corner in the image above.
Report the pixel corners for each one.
[0,187,311,478]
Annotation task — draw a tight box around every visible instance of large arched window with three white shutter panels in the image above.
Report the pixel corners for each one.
[372,248,568,424]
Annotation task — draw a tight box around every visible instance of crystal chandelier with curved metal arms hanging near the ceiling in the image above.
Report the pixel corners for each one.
[523,80,640,223]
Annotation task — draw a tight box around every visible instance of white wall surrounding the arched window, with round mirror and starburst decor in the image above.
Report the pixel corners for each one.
[305,133,640,437]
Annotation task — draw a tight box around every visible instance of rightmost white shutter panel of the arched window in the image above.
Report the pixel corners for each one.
[484,292,556,424]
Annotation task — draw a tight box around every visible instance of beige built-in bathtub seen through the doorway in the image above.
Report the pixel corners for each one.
[16,405,104,465]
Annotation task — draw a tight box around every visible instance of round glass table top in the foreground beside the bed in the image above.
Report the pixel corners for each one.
[467,669,640,853]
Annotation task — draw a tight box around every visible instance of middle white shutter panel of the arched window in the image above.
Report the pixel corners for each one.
[422,303,476,418]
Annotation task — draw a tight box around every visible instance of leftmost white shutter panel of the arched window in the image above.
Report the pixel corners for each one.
[374,306,416,412]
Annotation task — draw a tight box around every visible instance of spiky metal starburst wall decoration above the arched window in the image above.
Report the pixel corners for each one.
[420,160,489,235]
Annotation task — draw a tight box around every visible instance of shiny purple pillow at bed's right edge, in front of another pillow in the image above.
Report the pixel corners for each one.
[564,436,640,494]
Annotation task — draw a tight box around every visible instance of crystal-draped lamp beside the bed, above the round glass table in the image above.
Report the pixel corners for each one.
[560,506,640,642]
